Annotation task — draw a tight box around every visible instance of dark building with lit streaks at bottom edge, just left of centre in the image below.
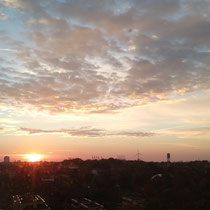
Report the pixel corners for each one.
[71,198,105,210]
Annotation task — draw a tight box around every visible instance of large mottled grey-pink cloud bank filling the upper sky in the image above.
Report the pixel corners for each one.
[0,0,210,113]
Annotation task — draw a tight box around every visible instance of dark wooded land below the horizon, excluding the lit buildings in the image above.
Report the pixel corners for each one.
[0,158,210,210]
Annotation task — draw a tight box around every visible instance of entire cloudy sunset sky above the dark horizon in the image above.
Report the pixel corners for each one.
[0,0,210,161]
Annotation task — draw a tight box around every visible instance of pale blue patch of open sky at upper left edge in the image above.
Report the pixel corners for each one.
[0,8,39,79]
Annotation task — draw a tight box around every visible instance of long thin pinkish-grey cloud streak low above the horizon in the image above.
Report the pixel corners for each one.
[18,126,154,137]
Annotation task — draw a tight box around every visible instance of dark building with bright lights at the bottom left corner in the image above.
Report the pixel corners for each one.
[13,193,50,210]
